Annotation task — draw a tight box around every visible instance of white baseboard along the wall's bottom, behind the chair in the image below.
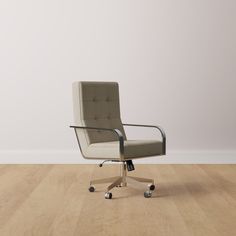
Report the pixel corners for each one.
[0,150,236,164]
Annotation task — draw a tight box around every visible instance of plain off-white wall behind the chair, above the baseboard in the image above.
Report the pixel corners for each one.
[0,0,236,162]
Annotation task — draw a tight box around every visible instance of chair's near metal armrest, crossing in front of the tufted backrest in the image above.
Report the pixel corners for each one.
[70,125,124,160]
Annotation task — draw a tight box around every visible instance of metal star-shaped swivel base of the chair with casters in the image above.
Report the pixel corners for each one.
[90,162,155,199]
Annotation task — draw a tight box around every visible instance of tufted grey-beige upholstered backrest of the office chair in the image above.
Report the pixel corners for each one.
[73,81,126,149]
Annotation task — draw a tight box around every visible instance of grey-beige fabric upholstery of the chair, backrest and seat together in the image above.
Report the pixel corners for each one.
[73,82,163,160]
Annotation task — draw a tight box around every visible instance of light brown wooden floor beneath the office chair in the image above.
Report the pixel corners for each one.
[0,165,236,236]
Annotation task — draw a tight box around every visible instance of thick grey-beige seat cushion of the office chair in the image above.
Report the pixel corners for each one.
[84,140,162,159]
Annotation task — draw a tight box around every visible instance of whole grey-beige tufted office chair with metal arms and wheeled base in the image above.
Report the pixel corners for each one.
[70,81,166,199]
